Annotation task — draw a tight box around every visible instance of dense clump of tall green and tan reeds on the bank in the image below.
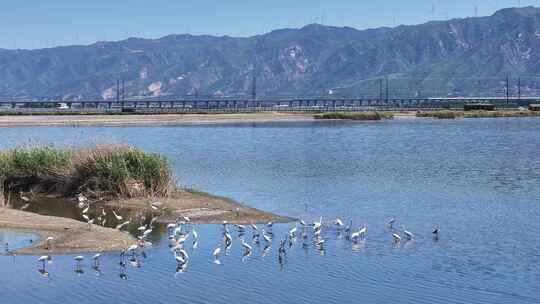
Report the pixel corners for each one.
[0,145,174,201]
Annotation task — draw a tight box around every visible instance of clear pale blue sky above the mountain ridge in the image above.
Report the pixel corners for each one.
[0,0,540,49]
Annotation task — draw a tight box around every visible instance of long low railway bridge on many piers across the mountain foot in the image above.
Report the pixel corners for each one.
[0,97,540,113]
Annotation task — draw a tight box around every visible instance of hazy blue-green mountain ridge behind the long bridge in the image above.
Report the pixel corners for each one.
[0,7,540,99]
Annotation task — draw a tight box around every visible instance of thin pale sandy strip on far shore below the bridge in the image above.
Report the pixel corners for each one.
[0,112,315,127]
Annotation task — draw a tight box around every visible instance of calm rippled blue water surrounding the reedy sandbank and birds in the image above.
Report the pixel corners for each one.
[0,118,540,303]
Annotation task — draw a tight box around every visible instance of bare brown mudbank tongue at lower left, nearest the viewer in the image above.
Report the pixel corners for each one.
[0,208,136,254]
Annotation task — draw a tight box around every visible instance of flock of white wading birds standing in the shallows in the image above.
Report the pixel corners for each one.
[30,191,439,279]
